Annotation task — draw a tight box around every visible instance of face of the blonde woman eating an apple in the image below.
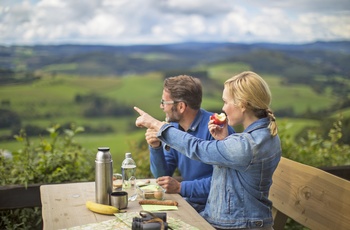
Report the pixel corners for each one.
[222,87,245,126]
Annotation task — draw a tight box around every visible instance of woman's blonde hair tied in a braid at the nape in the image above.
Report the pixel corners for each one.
[224,71,277,136]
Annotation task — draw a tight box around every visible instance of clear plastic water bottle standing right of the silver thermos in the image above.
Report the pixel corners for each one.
[121,153,137,201]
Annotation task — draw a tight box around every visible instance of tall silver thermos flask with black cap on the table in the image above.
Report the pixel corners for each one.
[95,147,113,205]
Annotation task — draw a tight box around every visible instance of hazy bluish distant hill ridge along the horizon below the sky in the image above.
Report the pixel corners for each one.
[0,41,350,77]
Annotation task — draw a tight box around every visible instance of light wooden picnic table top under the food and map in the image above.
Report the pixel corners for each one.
[40,182,214,230]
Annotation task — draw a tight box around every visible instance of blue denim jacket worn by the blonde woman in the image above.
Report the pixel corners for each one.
[158,118,282,229]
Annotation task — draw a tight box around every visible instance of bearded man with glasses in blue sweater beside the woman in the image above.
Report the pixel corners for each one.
[146,75,233,212]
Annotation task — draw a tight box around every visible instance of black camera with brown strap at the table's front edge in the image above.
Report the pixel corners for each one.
[131,211,171,230]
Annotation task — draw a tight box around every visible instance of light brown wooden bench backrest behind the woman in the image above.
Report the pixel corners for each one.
[269,157,350,230]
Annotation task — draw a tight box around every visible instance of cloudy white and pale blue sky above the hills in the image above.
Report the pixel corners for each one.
[0,0,350,45]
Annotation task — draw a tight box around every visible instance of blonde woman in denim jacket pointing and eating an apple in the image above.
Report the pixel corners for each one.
[135,72,281,229]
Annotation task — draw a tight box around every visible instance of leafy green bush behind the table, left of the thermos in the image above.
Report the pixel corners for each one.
[0,125,95,229]
